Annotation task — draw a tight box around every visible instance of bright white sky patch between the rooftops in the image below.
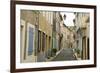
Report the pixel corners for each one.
[61,12,75,26]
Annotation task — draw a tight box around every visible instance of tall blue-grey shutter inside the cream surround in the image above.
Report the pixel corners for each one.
[28,27,34,55]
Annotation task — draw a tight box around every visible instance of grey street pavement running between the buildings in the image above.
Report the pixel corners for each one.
[52,49,76,61]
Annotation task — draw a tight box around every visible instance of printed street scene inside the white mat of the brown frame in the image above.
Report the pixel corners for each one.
[20,10,90,62]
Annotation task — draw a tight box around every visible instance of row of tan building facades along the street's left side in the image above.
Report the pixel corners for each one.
[20,10,62,62]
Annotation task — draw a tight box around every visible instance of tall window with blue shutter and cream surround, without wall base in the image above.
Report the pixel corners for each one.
[26,23,35,57]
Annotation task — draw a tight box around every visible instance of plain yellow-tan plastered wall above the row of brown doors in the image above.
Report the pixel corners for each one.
[39,13,52,51]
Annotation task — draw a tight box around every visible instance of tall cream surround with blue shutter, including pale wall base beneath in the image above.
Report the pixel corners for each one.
[25,23,36,62]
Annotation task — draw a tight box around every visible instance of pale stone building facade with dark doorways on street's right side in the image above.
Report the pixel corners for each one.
[75,13,90,59]
